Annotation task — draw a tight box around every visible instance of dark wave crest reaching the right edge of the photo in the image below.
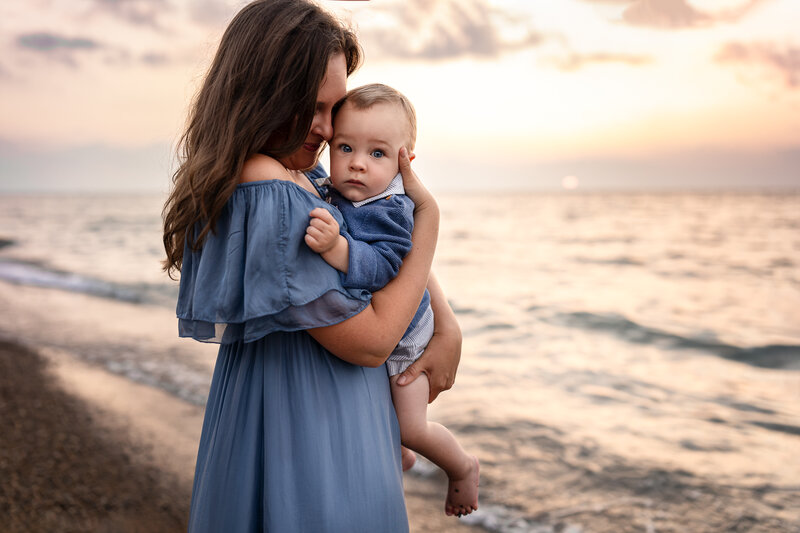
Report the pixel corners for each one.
[546,311,800,369]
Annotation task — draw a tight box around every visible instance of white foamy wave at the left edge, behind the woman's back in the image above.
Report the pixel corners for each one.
[0,258,178,307]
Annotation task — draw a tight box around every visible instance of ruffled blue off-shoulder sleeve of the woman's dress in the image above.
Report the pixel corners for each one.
[177,180,371,344]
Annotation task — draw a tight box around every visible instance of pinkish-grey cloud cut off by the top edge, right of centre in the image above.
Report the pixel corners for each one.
[584,0,766,29]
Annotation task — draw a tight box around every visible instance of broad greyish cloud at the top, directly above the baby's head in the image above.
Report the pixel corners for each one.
[359,0,543,60]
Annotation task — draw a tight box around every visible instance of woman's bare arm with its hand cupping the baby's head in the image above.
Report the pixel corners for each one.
[308,149,439,367]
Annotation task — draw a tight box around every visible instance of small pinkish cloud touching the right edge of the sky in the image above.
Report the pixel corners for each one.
[714,42,800,89]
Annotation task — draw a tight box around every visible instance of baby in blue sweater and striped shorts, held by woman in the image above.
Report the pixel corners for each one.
[305,84,479,516]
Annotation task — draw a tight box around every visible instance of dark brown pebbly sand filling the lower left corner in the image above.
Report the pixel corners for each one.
[0,342,188,533]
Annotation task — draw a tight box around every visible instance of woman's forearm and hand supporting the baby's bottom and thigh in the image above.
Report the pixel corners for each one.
[397,272,461,402]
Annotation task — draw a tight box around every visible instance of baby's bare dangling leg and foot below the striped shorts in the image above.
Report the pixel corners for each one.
[391,374,479,515]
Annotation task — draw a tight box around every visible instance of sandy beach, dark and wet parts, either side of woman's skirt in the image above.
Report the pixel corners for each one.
[0,338,482,533]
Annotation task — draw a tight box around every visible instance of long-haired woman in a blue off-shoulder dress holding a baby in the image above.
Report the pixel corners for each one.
[164,0,460,532]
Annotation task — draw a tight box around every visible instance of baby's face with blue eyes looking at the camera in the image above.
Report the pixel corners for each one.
[330,102,409,202]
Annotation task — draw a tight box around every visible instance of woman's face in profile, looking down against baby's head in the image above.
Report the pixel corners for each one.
[280,54,347,170]
